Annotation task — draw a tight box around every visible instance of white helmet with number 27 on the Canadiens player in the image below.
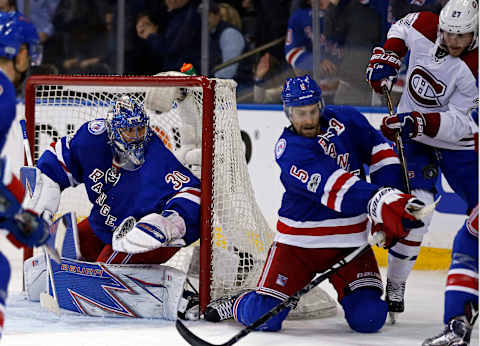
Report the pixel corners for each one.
[438,0,478,50]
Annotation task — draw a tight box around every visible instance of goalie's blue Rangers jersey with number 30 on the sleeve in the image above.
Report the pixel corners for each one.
[37,119,200,244]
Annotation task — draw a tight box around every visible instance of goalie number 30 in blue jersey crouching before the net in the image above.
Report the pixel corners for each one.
[23,96,200,319]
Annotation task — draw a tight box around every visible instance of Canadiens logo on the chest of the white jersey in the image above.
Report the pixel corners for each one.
[408,66,447,107]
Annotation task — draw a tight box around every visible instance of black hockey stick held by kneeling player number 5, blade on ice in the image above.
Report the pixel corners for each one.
[175,243,370,346]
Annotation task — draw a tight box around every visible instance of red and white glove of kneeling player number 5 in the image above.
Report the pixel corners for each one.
[367,187,425,249]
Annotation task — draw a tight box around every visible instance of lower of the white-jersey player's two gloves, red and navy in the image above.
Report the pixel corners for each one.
[380,112,440,141]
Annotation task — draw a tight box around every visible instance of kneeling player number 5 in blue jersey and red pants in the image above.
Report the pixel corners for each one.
[205,75,423,333]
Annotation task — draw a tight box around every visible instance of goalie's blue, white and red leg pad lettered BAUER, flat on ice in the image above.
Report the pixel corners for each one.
[41,258,186,320]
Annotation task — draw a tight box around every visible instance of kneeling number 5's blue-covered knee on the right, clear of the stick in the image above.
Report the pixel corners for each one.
[340,288,387,333]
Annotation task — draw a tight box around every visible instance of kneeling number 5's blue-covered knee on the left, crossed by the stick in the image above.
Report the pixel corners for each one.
[234,292,290,332]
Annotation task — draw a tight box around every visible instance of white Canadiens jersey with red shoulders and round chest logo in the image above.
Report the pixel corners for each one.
[385,12,478,150]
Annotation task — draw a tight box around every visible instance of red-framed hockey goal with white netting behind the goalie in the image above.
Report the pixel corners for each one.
[25,72,335,318]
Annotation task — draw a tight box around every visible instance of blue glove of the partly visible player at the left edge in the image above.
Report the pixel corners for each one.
[0,210,50,247]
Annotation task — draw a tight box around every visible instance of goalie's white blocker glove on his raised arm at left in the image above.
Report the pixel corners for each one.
[20,166,61,225]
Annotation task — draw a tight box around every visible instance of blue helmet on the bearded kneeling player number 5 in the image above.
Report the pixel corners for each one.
[282,74,324,118]
